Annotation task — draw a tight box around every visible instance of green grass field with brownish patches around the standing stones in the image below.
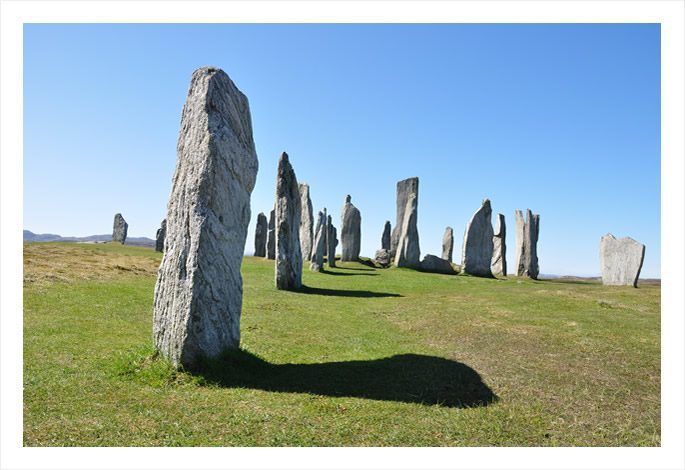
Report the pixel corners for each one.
[24,243,661,446]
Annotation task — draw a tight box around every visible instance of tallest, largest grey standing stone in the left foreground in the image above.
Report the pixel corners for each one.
[152,67,258,368]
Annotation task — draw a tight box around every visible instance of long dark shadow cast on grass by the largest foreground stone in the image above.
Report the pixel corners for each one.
[191,350,498,408]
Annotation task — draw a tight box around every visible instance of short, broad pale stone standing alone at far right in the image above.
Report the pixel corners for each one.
[599,233,645,287]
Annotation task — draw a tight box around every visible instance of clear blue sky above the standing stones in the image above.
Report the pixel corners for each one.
[24,24,661,277]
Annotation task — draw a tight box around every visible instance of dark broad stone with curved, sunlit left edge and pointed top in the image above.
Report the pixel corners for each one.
[461,199,493,277]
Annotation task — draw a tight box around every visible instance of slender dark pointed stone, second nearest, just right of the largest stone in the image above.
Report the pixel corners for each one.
[276,152,302,290]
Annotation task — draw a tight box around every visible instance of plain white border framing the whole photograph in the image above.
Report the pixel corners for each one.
[0,1,685,469]
